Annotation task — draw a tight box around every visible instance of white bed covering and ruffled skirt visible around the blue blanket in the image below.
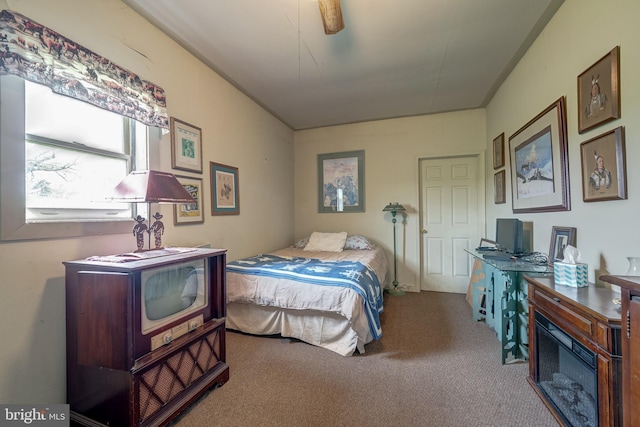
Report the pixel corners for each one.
[227,247,388,356]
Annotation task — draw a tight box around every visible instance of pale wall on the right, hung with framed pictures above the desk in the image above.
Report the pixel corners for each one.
[486,0,640,282]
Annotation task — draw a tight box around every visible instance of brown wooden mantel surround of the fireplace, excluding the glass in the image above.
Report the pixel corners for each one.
[525,276,622,426]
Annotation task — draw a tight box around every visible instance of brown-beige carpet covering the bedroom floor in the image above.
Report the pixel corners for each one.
[174,292,558,427]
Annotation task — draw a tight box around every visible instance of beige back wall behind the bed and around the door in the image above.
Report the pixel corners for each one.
[294,109,486,291]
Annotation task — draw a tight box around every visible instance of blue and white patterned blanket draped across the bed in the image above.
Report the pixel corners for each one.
[227,254,383,339]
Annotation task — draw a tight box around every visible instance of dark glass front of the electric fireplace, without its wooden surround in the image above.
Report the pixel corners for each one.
[535,311,598,427]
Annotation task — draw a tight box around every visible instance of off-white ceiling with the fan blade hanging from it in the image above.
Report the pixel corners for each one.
[123,0,563,130]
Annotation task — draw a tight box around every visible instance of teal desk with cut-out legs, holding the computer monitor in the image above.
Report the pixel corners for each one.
[467,251,553,364]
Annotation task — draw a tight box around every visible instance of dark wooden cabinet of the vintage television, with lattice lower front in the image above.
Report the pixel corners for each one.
[64,248,229,427]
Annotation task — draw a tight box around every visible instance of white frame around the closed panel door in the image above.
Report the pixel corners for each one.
[417,150,488,291]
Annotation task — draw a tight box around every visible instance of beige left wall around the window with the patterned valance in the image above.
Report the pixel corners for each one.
[0,0,293,403]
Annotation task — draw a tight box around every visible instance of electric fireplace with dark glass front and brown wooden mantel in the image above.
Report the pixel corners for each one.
[526,277,622,427]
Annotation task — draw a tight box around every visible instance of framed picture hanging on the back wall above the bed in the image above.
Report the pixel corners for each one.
[318,150,365,213]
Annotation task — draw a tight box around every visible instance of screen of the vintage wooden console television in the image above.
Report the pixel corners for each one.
[141,260,206,332]
